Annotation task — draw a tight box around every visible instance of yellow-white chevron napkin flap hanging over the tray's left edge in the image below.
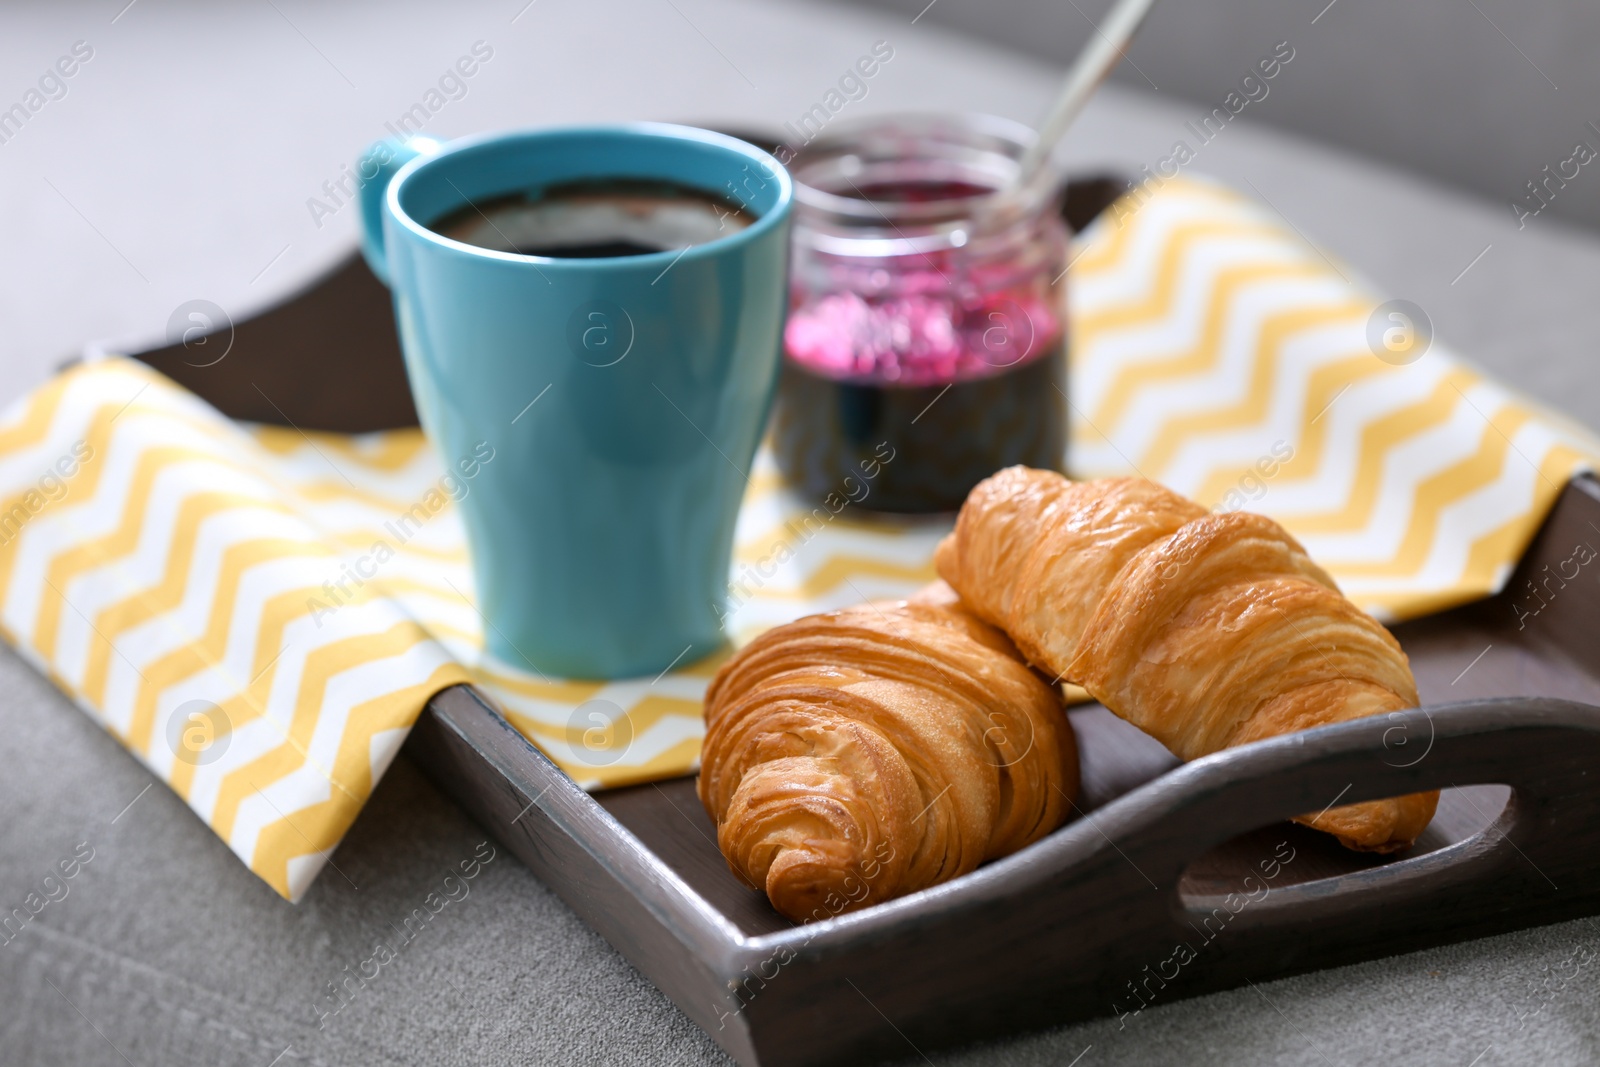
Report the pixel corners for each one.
[0,367,469,899]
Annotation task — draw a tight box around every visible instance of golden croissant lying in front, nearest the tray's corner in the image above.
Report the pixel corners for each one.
[699,582,1078,921]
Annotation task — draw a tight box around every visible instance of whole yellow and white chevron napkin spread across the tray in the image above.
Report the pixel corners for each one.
[0,181,1600,899]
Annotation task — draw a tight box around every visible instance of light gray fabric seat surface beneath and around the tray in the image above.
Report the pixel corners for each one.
[0,0,1600,1067]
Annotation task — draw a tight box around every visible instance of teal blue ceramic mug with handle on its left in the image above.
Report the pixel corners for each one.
[362,123,794,678]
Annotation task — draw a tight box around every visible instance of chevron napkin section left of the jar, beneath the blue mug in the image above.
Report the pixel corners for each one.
[0,360,942,901]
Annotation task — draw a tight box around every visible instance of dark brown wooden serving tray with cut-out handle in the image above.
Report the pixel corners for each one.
[128,173,1600,1065]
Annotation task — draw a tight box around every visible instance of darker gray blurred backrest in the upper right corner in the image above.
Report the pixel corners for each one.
[851,0,1600,226]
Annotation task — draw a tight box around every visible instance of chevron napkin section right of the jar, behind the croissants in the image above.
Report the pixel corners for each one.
[1069,179,1600,621]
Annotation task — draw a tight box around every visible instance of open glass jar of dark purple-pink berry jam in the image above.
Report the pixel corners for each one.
[773,115,1067,512]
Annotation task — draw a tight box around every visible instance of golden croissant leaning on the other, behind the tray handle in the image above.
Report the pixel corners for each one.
[936,467,1438,853]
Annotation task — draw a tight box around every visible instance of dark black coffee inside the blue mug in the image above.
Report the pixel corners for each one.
[429,179,755,259]
